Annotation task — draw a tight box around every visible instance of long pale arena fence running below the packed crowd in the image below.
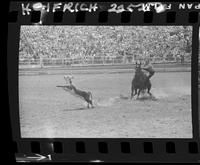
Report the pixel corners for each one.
[19,56,191,68]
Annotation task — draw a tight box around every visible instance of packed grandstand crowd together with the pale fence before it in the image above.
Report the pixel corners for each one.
[19,26,192,64]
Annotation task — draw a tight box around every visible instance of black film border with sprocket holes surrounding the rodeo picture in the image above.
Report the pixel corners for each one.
[7,3,200,162]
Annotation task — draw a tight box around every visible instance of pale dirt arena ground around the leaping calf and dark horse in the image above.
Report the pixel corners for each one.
[19,71,192,138]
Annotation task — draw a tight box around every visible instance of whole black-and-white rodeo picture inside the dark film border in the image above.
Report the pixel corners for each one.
[19,25,192,138]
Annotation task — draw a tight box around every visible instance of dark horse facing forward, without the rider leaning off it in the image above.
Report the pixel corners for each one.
[131,63,152,99]
